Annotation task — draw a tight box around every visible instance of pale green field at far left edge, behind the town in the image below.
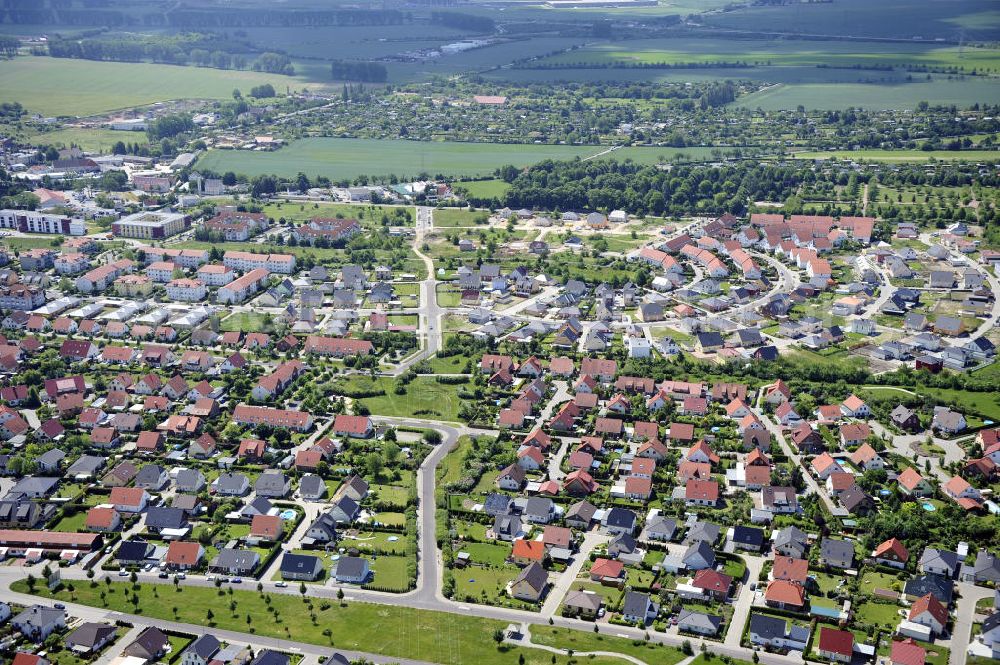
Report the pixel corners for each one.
[0,56,324,116]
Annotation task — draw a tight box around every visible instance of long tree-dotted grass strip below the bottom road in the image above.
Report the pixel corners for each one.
[14,581,608,665]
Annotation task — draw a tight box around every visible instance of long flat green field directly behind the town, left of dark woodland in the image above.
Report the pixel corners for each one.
[192,137,676,181]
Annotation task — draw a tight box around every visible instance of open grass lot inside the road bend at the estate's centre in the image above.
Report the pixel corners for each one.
[339,375,462,421]
